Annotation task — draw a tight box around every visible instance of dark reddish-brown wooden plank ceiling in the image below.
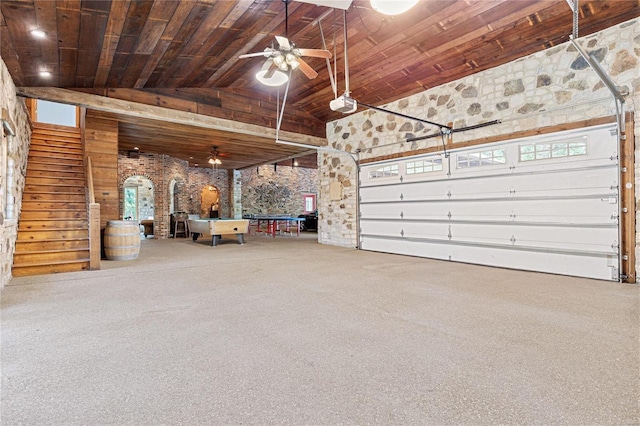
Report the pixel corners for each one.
[0,0,640,168]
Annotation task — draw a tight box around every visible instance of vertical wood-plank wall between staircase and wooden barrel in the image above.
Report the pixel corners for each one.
[84,110,120,228]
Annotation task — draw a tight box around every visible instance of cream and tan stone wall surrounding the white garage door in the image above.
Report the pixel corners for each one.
[318,19,640,253]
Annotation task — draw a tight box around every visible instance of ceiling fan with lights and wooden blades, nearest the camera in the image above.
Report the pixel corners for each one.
[239,0,331,79]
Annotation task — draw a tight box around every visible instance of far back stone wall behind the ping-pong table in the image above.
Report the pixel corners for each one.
[239,165,318,216]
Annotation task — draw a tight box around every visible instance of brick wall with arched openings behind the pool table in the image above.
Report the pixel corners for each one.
[118,152,230,238]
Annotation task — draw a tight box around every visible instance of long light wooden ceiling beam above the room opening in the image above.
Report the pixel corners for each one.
[16,87,327,146]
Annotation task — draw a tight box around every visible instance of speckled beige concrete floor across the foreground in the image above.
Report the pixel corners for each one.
[0,234,640,425]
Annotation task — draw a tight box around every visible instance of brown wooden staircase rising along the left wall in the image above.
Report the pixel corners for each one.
[12,123,90,277]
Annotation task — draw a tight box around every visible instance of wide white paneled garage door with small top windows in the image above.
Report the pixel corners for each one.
[360,125,619,281]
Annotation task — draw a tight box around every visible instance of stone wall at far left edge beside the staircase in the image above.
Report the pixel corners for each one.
[0,57,31,290]
